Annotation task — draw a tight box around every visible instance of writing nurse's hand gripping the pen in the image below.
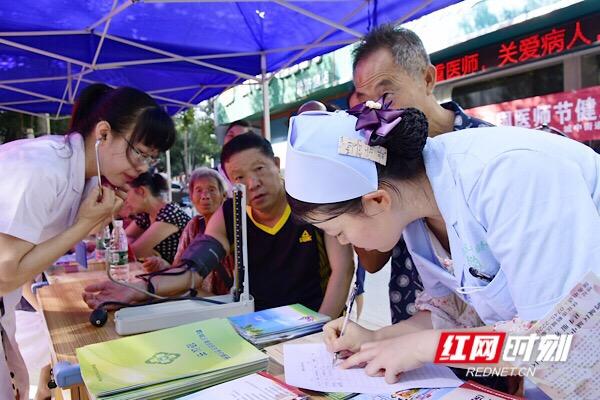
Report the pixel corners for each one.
[323,317,375,353]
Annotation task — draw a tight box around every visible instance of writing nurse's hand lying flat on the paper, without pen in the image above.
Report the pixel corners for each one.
[340,330,437,384]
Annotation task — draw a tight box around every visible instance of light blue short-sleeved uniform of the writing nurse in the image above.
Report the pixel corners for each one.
[404,127,600,324]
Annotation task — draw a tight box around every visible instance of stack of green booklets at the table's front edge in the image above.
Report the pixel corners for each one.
[77,319,268,400]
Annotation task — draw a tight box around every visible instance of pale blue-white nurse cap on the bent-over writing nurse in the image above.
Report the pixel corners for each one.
[285,111,381,204]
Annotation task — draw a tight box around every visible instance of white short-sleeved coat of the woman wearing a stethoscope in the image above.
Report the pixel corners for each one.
[0,133,85,399]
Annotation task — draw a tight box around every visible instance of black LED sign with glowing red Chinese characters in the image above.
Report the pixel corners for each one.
[435,14,600,82]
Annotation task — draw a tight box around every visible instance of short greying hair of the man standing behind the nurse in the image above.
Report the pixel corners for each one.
[352,24,431,76]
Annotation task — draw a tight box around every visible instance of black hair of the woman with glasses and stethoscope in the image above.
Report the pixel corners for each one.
[69,83,176,151]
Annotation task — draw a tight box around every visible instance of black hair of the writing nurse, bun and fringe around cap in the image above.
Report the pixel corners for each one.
[287,108,429,223]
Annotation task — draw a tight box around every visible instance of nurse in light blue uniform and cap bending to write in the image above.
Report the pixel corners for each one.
[285,103,600,382]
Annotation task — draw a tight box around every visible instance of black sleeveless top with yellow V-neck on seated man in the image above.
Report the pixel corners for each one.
[223,199,328,310]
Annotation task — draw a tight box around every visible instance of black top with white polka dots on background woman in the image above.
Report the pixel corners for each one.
[135,203,190,263]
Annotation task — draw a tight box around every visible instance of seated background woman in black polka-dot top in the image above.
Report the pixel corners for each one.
[126,172,190,263]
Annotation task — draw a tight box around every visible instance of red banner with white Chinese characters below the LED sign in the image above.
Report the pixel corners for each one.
[466,86,600,141]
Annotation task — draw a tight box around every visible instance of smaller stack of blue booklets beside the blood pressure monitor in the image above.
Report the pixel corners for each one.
[229,304,331,347]
